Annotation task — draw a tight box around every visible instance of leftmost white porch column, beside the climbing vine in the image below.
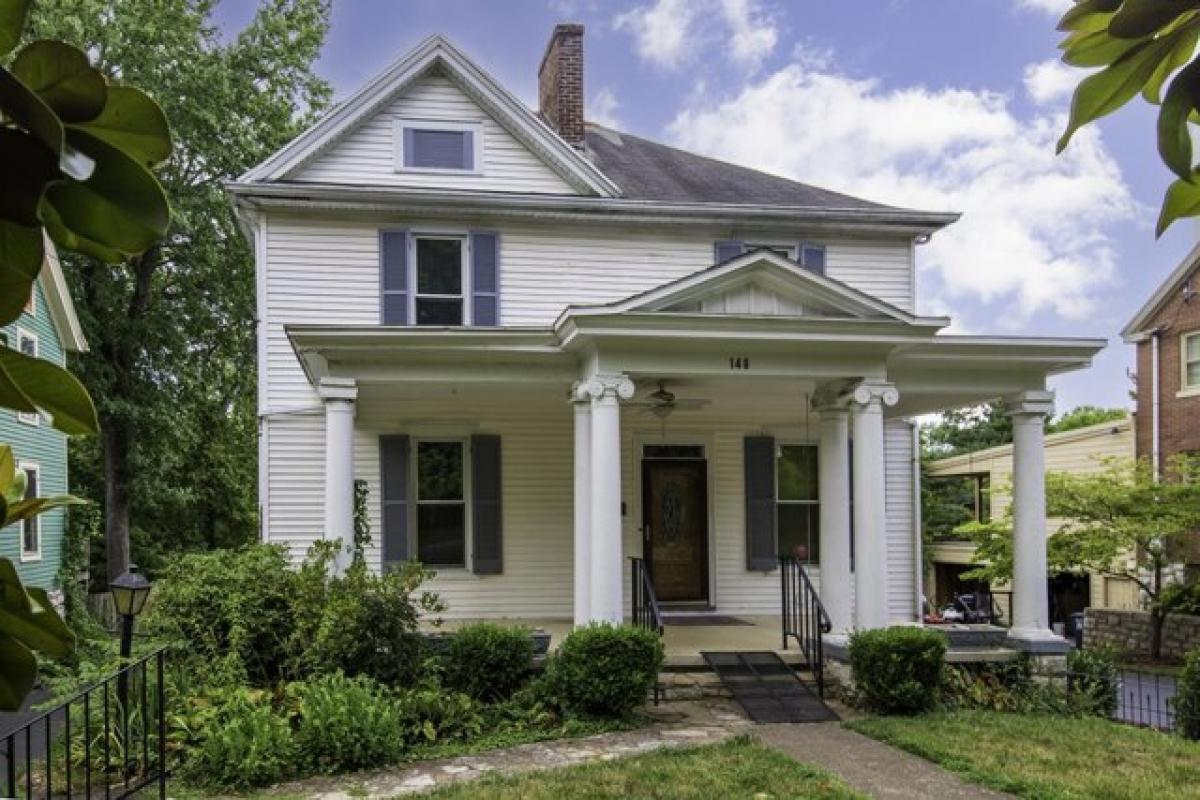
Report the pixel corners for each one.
[317,378,359,573]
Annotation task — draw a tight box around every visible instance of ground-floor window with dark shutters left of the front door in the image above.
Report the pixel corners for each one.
[415,439,467,567]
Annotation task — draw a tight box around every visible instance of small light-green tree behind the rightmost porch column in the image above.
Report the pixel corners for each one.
[959,456,1200,658]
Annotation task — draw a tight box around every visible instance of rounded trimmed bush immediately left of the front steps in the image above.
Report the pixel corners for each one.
[545,624,662,718]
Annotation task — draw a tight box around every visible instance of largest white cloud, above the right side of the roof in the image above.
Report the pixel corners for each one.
[668,64,1139,330]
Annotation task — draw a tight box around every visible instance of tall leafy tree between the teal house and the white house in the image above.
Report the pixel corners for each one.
[32,0,330,578]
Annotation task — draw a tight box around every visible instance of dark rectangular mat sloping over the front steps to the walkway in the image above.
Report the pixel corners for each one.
[700,651,838,722]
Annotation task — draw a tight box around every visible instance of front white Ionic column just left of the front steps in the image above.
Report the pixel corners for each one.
[587,375,634,624]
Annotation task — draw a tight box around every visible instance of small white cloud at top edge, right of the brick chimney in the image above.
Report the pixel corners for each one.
[613,0,779,70]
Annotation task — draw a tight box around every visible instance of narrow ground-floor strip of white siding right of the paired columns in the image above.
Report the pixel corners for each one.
[883,420,917,620]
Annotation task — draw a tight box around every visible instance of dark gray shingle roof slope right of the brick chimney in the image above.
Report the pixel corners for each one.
[586,122,889,209]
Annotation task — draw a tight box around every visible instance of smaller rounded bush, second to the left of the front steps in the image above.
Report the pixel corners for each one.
[444,622,533,703]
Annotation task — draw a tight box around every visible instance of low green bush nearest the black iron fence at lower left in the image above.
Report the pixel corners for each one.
[174,690,296,789]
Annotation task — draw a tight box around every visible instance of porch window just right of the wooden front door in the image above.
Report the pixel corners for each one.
[775,445,821,564]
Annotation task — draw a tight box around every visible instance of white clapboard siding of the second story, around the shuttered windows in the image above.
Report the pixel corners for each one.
[264,215,911,408]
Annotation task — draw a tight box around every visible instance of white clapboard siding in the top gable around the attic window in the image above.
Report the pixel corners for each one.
[293,76,577,194]
